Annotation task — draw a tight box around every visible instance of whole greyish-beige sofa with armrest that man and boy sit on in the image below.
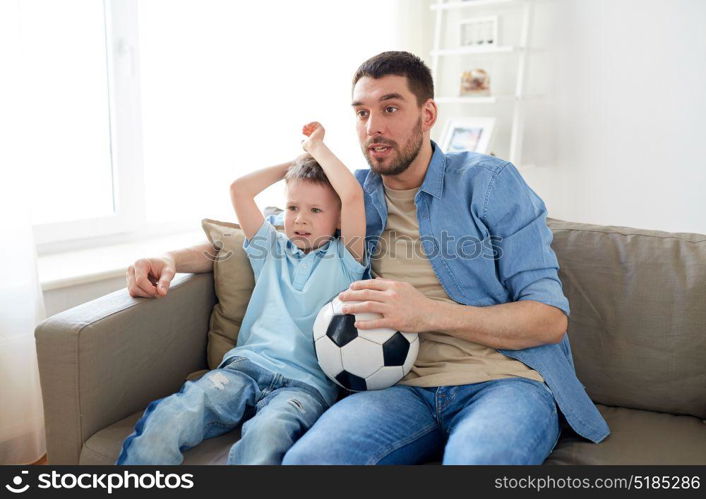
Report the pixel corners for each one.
[35,220,706,464]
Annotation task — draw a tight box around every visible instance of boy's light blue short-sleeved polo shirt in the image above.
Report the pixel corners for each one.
[223,222,365,405]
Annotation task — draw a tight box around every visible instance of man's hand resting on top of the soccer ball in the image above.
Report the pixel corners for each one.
[338,279,433,333]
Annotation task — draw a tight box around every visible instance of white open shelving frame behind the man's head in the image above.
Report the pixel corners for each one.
[431,0,533,168]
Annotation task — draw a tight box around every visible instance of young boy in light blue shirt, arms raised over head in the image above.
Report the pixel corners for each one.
[117,122,365,464]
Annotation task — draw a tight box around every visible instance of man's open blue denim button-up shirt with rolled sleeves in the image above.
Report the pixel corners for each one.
[355,142,610,442]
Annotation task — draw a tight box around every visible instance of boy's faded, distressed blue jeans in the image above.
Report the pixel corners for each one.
[116,357,327,464]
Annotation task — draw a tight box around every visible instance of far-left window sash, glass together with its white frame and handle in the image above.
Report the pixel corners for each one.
[26,0,144,253]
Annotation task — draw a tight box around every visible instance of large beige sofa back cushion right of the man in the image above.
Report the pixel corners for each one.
[548,219,706,419]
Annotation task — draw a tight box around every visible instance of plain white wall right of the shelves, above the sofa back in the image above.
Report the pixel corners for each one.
[522,0,706,233]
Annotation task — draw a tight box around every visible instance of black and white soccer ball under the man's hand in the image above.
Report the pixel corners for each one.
[314,298,419,392]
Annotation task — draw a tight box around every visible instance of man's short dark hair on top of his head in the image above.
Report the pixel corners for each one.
[353,51,434,107]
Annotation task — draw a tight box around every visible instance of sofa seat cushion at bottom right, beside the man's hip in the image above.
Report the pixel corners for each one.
[544,405,706,465]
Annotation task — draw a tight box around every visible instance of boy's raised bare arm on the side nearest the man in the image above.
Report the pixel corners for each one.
[302,121,365,262]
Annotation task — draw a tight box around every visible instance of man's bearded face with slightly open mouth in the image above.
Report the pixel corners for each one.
[353,75,424,175]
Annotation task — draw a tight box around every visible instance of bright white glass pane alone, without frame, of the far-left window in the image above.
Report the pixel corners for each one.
[20,0,114,234]
